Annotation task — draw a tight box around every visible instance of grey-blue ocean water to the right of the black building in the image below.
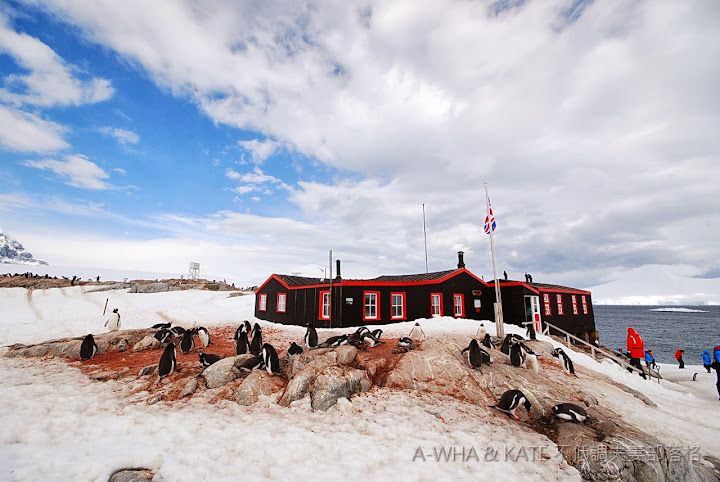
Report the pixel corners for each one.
[593,305,720,365]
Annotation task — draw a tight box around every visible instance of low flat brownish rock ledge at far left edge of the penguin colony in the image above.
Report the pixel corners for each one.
[5,329,157,358]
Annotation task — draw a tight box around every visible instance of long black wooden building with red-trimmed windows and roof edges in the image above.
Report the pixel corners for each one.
[255,252,596,341]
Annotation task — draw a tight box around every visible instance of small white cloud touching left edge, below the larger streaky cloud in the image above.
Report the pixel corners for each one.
[0,105,70,153]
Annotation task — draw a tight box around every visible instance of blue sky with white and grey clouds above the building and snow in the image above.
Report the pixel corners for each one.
[0,0,720,301]
